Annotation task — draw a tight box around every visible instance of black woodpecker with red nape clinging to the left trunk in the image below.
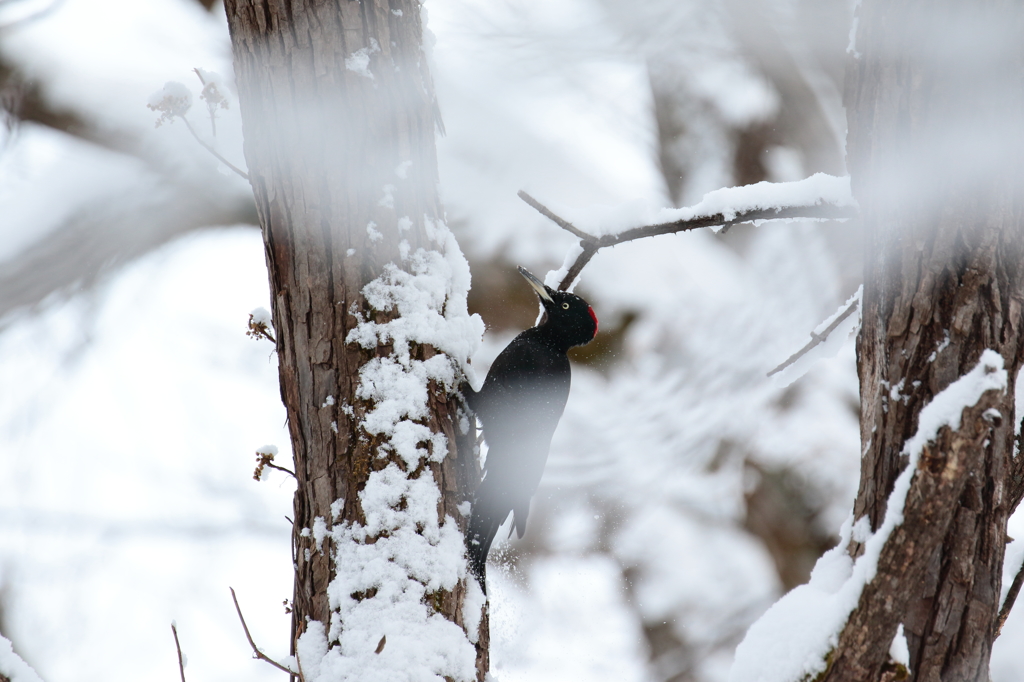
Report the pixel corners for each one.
[467,267,597,584]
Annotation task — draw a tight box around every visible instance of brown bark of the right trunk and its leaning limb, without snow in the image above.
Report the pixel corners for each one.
[820,0,1024,682]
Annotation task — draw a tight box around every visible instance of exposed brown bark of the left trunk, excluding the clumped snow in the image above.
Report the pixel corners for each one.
[219,0,488,679]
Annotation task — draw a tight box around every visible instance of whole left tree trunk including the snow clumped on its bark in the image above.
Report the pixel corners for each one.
[225,0,487,682]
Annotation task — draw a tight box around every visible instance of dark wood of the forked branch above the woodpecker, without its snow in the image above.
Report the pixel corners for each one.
[518,190,856,291]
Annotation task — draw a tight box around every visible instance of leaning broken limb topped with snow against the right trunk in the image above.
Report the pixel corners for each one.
[730,350,1009,682]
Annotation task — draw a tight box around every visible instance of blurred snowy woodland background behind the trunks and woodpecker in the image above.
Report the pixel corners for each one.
[0,0,1024,682]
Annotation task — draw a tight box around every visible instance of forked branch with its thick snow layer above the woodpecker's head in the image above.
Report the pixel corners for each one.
[518,173,857,291]
